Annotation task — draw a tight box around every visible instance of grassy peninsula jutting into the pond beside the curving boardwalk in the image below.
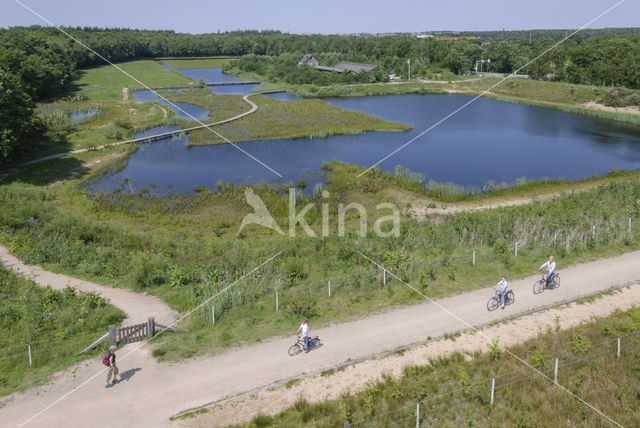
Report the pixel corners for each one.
[159,89,411,145]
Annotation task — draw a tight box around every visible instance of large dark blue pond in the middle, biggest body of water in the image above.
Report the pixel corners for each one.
[89,95,640,196]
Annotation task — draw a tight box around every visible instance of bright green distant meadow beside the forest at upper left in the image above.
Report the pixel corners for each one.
[70,60,192,101]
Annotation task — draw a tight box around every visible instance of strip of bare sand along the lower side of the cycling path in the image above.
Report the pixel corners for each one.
[179,285,640,427]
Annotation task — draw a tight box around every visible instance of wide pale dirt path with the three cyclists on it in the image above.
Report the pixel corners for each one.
[0,251,640,427]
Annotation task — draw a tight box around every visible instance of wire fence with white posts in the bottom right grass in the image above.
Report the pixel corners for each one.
[344,331,640,427]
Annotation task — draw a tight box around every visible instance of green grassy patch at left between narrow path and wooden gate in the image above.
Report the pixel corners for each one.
[0,267,124,396]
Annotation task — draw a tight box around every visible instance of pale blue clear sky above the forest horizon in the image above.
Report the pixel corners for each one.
[0,0,640,33]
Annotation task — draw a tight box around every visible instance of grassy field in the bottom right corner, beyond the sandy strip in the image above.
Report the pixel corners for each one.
[232,308,640,427]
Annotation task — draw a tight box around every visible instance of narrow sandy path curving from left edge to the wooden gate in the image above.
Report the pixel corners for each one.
[0,245,176,325]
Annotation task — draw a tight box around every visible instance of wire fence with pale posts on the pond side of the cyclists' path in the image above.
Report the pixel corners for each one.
[199,217,640,324]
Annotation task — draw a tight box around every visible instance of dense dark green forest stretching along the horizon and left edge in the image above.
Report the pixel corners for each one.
[0,26,640,162]
